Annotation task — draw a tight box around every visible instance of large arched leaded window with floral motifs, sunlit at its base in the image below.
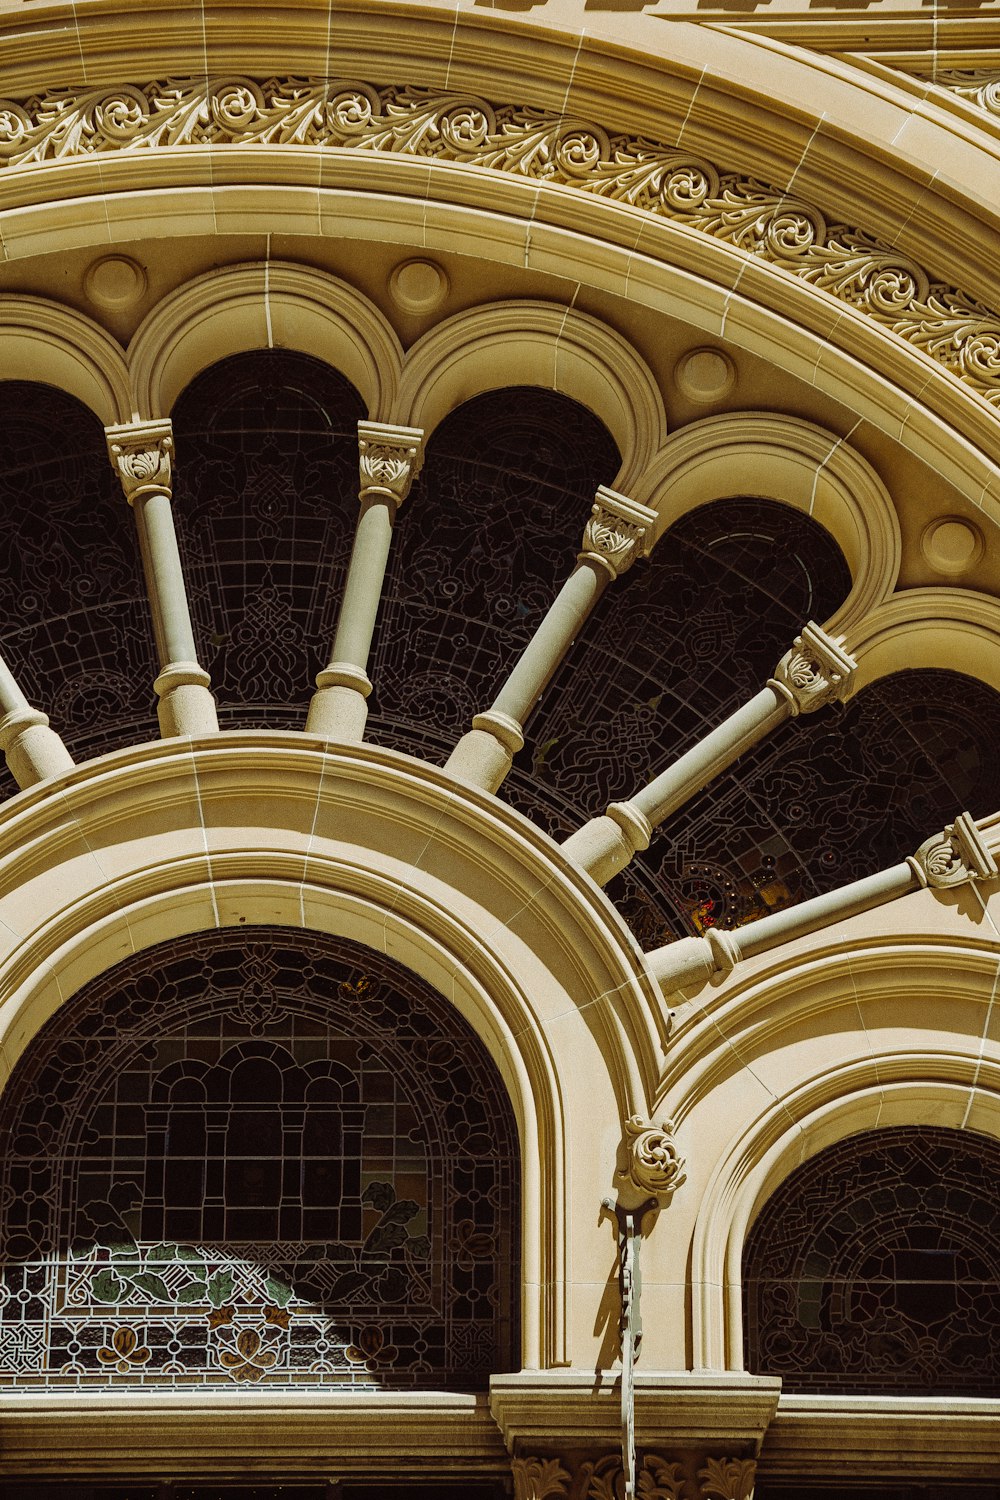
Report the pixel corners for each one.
[0,929,517,1389]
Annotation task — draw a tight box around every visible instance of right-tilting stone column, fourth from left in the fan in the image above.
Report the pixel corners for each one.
[445,486,657,792]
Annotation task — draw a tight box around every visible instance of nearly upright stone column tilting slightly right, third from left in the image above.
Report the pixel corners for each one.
[306,422,424,741]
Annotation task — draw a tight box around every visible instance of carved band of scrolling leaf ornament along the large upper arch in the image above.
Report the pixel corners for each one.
[0,77,1000,408]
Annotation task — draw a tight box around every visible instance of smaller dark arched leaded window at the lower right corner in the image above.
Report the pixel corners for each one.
[744,1127,1000,1397]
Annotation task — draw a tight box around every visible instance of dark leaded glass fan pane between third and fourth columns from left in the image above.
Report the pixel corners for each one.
[369,387,621,762]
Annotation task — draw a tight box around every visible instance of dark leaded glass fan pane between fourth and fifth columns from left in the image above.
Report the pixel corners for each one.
[505,500,850,864]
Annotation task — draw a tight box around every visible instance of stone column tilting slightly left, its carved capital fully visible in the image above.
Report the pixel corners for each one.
[105,419,219,740]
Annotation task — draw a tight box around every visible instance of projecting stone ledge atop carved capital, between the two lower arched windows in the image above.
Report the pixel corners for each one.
[490,1370,781,1452]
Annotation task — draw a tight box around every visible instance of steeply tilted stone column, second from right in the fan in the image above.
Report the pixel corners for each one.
[562,623,858,885]
